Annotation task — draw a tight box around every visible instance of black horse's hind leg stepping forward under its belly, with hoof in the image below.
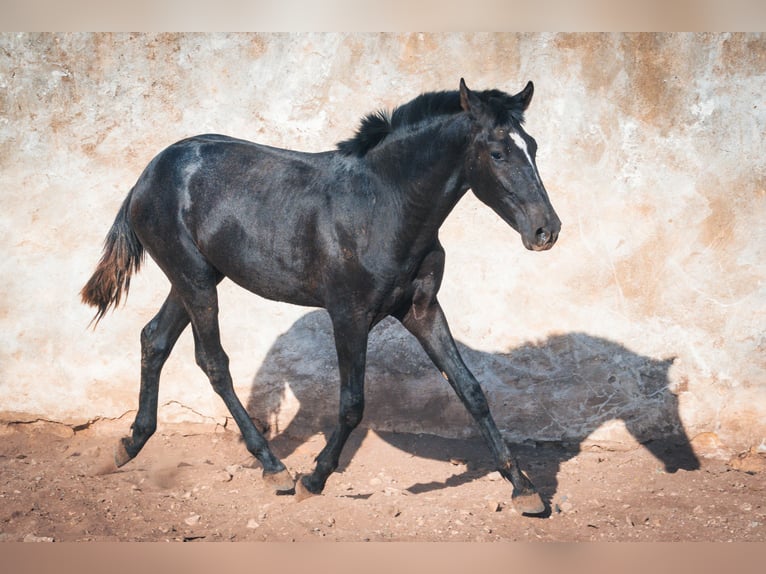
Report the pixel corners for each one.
[184,283,294,492]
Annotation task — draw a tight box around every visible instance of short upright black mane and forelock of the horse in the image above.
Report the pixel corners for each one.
[337,90,524,157]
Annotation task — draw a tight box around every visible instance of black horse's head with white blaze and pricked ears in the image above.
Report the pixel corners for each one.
[460,78,561,251]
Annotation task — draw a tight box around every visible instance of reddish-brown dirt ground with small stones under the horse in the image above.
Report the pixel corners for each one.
[0,422,766,542]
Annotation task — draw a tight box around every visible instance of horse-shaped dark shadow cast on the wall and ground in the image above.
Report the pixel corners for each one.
[247,311,699,506]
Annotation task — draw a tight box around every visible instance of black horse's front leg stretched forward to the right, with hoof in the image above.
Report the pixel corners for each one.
[401,300,545,514]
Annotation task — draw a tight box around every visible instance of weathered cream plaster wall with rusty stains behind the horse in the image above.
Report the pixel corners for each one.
[0,34,766,460]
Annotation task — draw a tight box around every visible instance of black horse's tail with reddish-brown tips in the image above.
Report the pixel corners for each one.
[80,190,144,327]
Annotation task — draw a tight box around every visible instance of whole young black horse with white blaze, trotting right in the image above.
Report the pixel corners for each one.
[81,79,561,514]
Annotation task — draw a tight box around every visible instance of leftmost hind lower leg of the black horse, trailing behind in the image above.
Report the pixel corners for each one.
[114,290,189,467]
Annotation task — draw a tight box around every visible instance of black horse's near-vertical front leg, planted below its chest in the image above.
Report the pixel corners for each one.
[296,314,369,494]
